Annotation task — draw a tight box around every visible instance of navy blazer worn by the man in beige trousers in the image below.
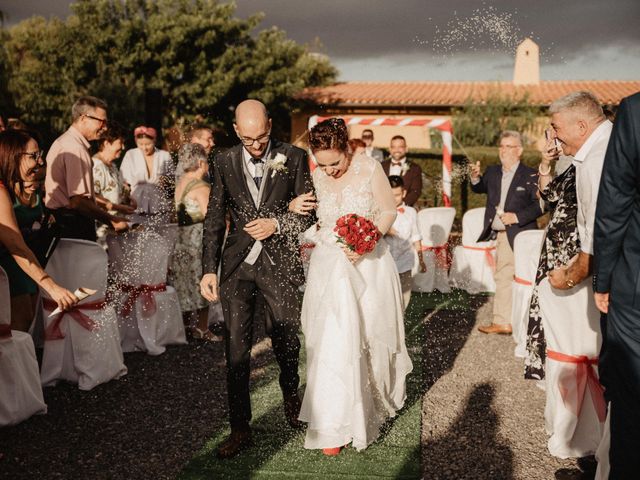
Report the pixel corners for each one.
[471,162,542,248]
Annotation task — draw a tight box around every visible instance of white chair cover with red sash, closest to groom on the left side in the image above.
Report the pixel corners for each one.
[107,224,185,355]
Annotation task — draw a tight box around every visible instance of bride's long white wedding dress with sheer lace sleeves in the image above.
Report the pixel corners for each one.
[300,155,412,450]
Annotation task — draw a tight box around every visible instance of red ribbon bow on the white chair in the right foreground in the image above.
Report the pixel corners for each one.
[547,350,607,422]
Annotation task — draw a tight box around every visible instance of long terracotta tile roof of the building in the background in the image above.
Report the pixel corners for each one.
[297,80,640,107]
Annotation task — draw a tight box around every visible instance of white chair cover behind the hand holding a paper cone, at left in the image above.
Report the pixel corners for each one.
[40,238,127,390]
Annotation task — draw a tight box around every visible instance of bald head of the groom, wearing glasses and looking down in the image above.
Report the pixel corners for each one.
[233,100,271,158]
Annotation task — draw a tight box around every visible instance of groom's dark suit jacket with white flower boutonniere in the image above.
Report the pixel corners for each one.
[202,139,315,285]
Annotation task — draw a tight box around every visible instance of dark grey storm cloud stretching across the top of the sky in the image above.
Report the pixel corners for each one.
[238,0,640,63]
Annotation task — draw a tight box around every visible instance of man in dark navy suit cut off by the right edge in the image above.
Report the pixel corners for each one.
[593,93,640,479]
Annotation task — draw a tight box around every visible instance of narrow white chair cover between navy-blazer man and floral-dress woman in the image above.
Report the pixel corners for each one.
[511,230,545,358]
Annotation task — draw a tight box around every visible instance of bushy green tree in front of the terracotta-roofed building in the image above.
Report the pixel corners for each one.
[452,90,543,146]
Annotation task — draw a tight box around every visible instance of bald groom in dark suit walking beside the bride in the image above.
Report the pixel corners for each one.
[200,100,313,458]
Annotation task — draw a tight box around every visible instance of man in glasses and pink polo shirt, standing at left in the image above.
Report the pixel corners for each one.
[45,97,128,241]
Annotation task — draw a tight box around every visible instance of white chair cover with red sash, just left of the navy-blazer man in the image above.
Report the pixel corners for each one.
[449,207,496,294]
